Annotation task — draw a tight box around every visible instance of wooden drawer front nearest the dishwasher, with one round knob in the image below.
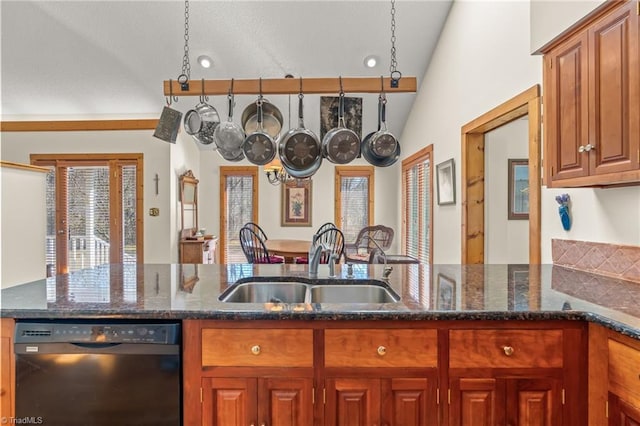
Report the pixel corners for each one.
[202,328,313,367]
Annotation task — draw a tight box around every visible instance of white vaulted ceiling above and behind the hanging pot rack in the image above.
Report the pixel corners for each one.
[0,0,451,142]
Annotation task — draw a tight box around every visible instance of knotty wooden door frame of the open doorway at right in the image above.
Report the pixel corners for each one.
[461,84,542,265]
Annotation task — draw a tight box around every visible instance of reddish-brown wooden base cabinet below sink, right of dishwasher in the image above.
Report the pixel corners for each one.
[183,320,588,426]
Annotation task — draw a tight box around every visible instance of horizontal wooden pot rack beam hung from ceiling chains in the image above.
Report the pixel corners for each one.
[163,76,417,97]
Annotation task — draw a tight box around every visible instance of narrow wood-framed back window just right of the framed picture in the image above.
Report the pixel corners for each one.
[334,166,374,242]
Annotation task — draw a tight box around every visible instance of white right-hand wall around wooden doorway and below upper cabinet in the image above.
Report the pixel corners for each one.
[397,1,640,263]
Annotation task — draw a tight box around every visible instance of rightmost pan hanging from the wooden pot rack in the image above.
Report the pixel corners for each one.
[362,85,400,167]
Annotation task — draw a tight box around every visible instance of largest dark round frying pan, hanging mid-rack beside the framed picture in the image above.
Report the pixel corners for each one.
[278,78,322,179]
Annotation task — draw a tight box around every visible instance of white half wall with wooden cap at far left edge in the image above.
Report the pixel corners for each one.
[0,166,47,288]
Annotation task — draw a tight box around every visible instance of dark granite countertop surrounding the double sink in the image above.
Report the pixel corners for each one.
[0,264,640,339]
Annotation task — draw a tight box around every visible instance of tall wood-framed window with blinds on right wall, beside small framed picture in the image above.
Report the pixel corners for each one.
[402,145,433,263]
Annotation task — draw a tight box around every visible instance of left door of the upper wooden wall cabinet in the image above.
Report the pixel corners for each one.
[544,33,589,181]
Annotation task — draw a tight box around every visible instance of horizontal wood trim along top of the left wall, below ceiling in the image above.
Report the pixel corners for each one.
[0,118,158,132]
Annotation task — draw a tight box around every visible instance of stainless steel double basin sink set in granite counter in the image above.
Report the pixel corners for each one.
[219,277,400,304]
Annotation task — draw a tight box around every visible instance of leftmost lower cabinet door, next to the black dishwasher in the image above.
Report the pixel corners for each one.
[202,378,258,426]
